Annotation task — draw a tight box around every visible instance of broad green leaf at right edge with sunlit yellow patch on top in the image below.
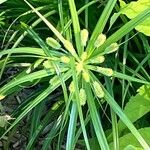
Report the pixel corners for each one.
[119,85,150,132]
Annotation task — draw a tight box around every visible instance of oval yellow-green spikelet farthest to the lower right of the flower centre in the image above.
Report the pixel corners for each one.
[93,81,104,98]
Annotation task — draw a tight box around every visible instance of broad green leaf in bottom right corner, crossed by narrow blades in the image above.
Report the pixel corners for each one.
[109,127,150,150]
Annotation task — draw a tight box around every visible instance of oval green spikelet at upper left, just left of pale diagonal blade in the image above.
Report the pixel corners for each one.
[46,37,61,49]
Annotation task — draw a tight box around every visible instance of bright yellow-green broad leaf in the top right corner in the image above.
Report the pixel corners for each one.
[119,0,150,36]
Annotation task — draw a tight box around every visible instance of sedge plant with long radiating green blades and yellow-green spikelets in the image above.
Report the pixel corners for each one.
[0,0,150,150]
